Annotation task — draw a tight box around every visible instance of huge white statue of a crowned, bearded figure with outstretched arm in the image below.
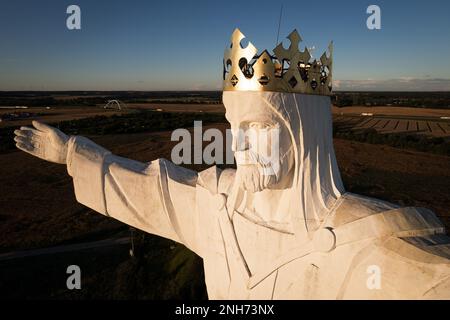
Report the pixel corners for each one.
[15,28,450,299]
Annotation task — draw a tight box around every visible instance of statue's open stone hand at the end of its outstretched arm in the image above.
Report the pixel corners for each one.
[14,121,69,164]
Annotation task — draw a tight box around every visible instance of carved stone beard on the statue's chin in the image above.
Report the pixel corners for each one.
[234,150,280,193]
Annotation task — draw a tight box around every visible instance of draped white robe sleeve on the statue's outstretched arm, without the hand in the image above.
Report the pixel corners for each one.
[67,136,200,255]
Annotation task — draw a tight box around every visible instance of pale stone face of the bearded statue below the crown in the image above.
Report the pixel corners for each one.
[224,99,294,192]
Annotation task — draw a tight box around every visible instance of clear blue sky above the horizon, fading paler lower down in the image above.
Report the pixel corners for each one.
[0,0,450,90]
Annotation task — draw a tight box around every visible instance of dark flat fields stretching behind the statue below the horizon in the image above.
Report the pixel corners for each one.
[0,94,450,299]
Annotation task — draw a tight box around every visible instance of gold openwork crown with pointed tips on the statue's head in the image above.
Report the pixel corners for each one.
[223,29,333,95]
